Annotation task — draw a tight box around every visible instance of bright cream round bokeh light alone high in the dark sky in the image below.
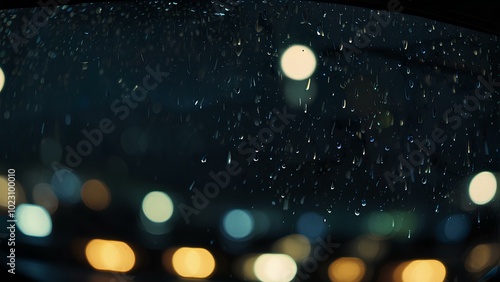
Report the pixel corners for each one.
[280,45,317,80]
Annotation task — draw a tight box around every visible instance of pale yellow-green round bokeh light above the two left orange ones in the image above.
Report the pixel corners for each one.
[142,191,174,223]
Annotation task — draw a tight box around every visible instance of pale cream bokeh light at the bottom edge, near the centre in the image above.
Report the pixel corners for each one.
[253,254,297,282]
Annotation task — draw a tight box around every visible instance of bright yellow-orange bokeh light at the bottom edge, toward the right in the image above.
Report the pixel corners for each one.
[401,260,446,282]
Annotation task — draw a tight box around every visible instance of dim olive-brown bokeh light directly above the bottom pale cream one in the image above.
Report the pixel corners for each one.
[272,234,311,261]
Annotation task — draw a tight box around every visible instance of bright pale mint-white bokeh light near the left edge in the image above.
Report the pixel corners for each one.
[16,204,52,237]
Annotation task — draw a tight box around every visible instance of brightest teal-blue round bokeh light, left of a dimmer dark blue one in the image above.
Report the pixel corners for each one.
[222,209,254,240]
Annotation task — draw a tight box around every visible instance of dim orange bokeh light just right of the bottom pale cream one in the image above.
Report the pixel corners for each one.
[328,257,366,282]
